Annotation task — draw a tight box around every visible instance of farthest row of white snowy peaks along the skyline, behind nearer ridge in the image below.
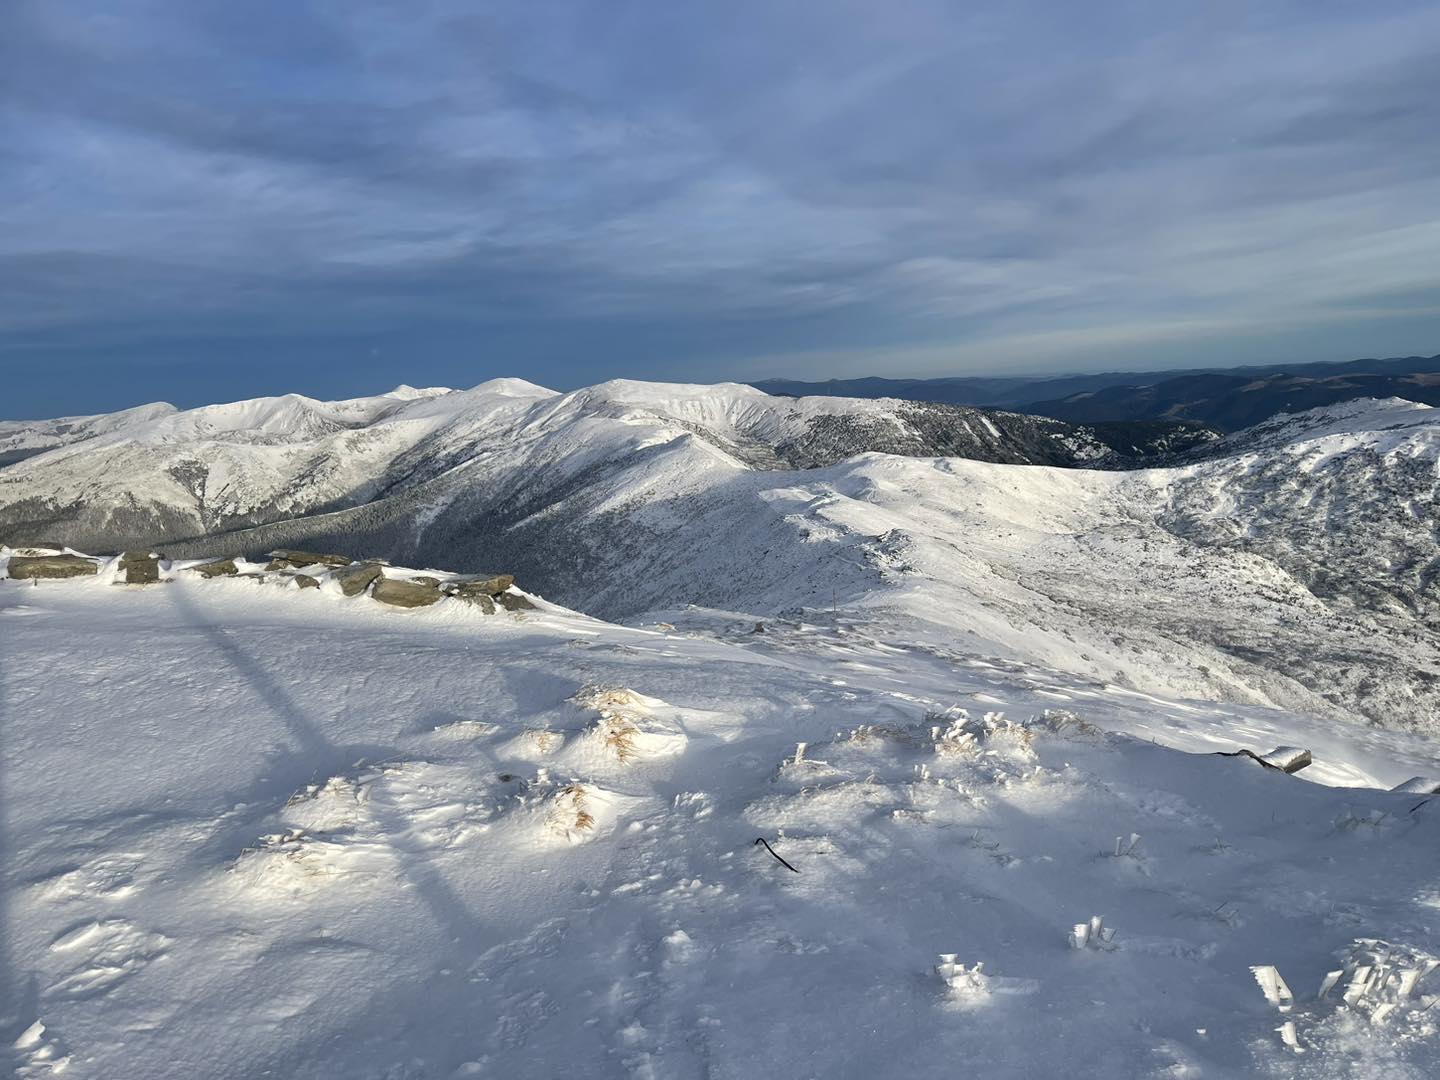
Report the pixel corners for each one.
[0,379,1208,550]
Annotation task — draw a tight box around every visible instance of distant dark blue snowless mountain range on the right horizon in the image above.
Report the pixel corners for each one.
[753,356,1440,432]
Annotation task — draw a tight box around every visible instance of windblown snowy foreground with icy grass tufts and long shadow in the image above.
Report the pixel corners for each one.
[0,575,1440,1080]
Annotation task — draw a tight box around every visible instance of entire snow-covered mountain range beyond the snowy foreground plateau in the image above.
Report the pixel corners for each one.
[0,380,1440,729]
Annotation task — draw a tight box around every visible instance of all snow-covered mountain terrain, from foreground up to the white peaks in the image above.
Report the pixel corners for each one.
[0,380,1440,1080]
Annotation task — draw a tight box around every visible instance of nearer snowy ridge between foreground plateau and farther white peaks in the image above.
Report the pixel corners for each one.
[151,395,1440,729]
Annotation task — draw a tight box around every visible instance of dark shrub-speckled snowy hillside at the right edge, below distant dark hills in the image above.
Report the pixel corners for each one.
[1157,399,1440,702]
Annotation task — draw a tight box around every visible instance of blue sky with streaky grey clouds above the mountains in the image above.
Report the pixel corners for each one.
[0,0,1440,418]
